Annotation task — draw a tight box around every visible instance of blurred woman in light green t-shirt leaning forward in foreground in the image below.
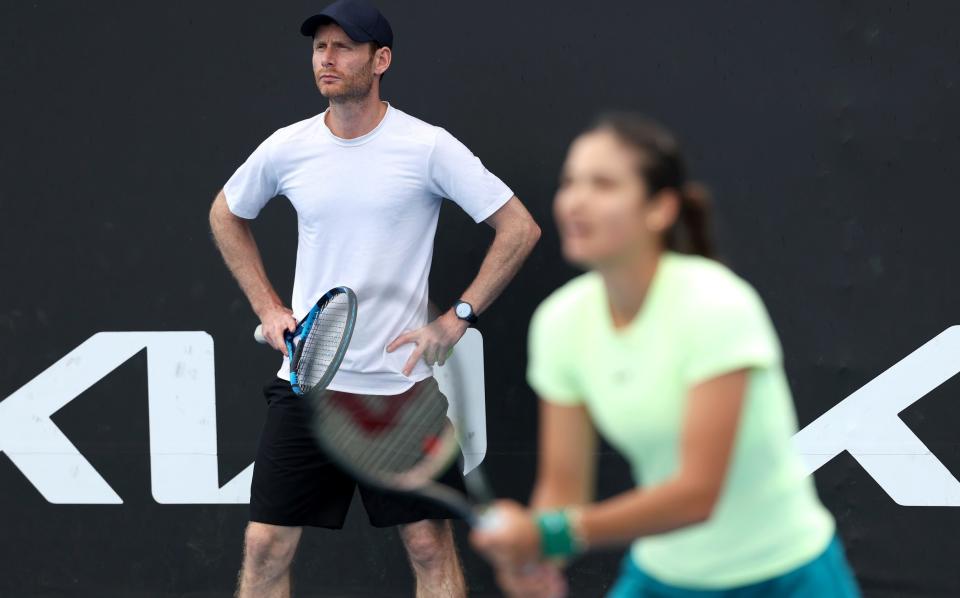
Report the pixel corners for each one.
[472,114,859,598]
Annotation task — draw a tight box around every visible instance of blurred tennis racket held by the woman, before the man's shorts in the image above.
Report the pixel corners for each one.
[307,332,496,527]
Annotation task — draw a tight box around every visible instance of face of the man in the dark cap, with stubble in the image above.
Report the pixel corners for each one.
[313,23,377,101]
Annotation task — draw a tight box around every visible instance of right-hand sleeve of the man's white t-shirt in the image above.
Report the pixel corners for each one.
[428,129,513,222]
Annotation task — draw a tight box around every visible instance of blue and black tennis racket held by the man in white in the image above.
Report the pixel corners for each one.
[253,287,357,395]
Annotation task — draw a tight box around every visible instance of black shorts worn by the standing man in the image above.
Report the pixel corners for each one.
[250,378,464,529]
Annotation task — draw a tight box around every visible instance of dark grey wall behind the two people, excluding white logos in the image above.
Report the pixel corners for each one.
[0,0,960,597]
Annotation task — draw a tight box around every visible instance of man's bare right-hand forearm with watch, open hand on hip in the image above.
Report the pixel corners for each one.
[387,196,540,376]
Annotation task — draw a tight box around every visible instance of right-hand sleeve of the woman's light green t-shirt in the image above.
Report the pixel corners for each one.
[683,283,781,386]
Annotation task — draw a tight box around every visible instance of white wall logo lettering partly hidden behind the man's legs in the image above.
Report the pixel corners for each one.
[0,329,487,504]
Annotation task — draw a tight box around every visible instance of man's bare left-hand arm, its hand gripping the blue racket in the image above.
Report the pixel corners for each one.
[210,191,297,355]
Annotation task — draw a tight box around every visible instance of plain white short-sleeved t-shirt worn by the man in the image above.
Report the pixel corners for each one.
[223,105,513,394]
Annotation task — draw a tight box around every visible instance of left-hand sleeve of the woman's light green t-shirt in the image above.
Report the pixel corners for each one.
[527,304,584,406]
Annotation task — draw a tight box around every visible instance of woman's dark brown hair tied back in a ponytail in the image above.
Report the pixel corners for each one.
[589,112,715,258]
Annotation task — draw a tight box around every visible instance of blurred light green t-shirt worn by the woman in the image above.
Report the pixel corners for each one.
[527,253,834,588]
